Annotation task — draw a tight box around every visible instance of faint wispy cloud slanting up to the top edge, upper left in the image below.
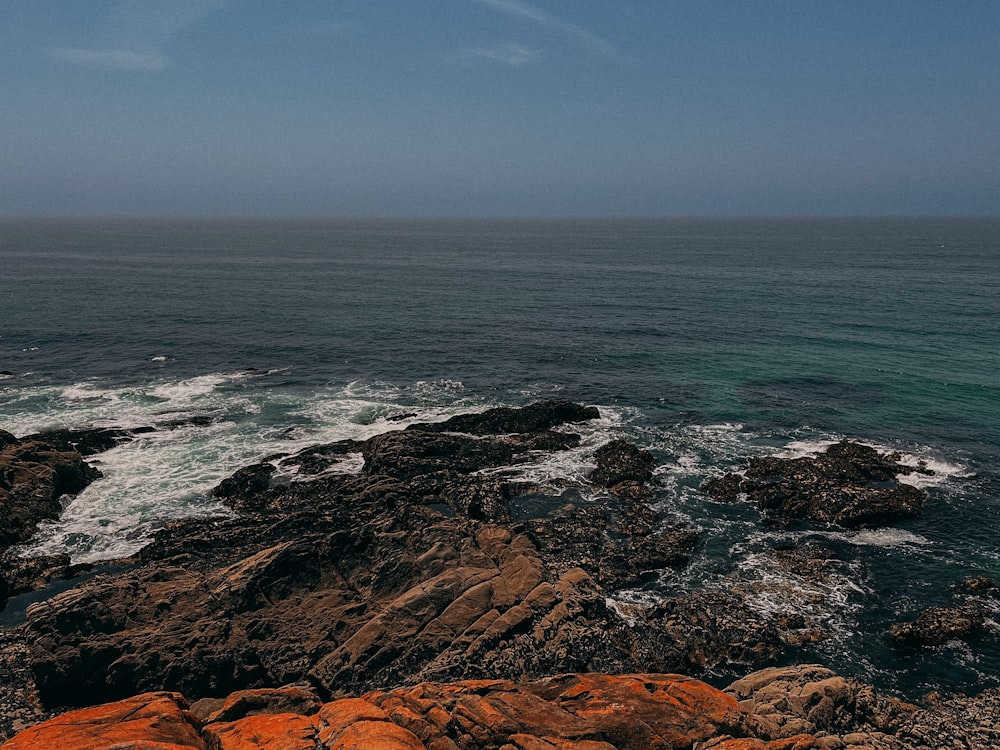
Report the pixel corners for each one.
[52,0,226,71]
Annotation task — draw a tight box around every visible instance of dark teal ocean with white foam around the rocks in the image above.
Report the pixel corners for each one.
[0,218,1000,695]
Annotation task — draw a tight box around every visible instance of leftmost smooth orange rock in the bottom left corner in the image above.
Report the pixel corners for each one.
[2,693,206,750]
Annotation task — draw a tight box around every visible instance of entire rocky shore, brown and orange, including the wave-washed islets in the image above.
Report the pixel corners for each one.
[0,401,1000,750]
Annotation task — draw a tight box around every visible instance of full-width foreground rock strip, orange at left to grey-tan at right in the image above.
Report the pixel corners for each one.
[2,665,1000,750]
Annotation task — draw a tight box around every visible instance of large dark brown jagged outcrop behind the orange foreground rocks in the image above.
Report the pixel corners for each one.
[27,402,733,705]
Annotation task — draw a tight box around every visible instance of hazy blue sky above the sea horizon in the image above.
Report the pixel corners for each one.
[0,0,1000,217]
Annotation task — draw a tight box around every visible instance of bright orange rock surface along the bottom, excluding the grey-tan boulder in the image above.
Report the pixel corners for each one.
[2,674,827,750]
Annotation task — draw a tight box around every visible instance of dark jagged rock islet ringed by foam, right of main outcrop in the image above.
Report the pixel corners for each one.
[703,440,931,527]
